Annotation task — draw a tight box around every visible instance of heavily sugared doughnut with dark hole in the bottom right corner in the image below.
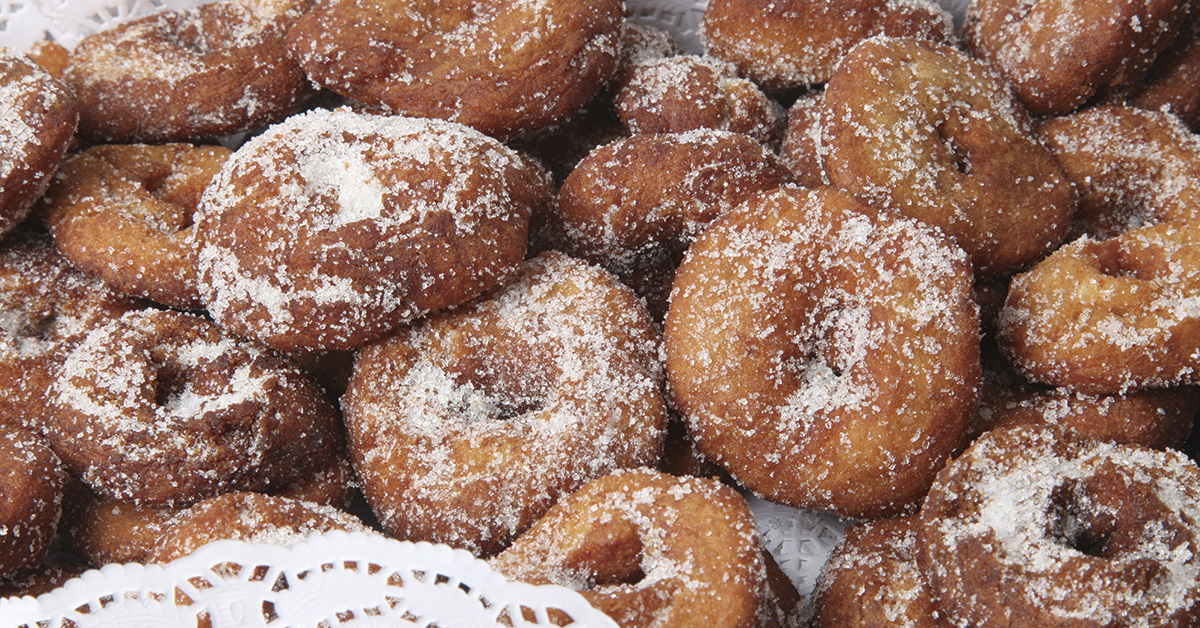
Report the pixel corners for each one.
[917,427,1200,628]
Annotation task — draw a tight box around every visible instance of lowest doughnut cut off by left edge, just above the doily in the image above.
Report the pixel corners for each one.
[0,427,66,576]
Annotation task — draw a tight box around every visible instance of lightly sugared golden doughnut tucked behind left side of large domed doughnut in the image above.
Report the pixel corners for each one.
[41,144,230,310]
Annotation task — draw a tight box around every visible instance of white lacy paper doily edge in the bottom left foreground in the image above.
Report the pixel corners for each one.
[0,532,617,628]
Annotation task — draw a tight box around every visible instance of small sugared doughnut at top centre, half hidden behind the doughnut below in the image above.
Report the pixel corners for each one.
[616,55,785,146]
